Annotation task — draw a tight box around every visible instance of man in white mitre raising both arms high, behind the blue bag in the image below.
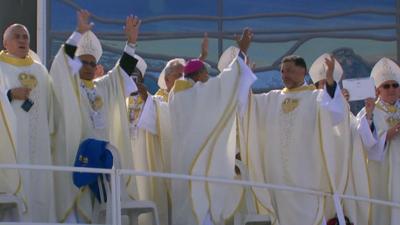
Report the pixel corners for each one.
[50,10,140,223]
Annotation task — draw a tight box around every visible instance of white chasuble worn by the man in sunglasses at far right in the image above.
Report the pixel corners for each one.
[358,99,400,225]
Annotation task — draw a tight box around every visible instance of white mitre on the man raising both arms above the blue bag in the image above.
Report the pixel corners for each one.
[75,30,103,62]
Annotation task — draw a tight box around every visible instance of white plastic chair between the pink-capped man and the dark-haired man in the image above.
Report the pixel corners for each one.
[234,160,271,225]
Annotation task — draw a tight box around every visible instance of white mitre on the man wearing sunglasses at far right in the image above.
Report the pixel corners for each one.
[371,57,400,87]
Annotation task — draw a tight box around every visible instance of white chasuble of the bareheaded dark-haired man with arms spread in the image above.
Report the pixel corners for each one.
[245,86,365,225]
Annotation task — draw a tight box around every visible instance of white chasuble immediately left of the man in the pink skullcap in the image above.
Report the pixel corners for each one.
[128,95,171,225]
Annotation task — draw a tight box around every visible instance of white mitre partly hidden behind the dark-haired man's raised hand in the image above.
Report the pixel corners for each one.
[309,53,343,83]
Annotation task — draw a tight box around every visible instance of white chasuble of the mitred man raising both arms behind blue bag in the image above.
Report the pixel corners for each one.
[50,47,136,222]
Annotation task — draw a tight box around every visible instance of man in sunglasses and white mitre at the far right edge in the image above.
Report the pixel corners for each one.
[357,58,400,225]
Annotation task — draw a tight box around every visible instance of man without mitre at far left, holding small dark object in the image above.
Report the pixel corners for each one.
[0,24,54,222]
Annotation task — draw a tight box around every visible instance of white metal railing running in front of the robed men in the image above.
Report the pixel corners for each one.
[0,164,400,225]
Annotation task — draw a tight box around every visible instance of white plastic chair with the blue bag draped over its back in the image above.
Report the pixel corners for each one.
[92,144,160,225]
